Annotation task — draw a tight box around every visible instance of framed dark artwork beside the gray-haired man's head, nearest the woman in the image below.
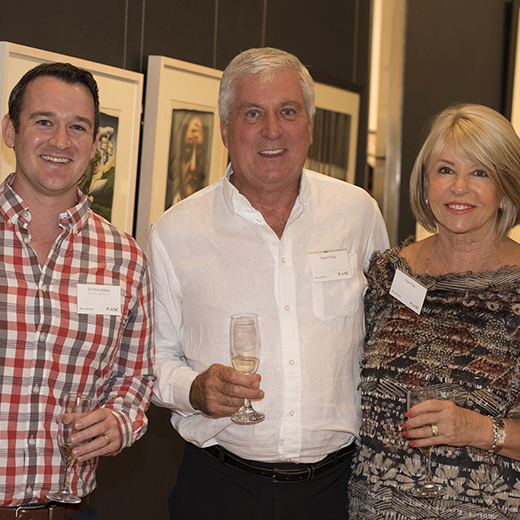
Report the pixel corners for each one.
[305,82,361,184]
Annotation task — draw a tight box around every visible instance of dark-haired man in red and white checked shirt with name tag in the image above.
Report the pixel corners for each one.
[0,63,153,520]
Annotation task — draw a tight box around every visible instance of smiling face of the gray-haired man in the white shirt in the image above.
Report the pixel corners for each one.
[220,70,312,199]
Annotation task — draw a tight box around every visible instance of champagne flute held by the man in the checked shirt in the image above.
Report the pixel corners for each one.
[47,394,94,504]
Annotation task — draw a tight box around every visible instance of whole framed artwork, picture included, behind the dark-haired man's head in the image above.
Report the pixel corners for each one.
[0,42,144,234]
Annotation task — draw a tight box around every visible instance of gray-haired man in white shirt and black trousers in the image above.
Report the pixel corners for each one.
[148,48,388,520]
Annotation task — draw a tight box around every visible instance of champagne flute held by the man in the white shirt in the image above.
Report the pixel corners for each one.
[230,313,265,424]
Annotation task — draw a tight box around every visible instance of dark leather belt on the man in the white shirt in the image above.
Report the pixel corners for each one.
[202,442,356,482]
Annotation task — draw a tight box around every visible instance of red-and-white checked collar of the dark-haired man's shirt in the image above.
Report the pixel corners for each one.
[0,173,88,234]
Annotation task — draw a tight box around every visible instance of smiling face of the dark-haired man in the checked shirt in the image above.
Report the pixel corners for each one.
[2,76,98,205]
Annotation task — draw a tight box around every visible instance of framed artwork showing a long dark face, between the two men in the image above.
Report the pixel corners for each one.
[136,56,227,244]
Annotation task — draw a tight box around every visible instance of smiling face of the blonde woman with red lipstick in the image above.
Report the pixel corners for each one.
[427,147,504,240]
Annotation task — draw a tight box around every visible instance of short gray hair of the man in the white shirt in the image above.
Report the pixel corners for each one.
[218,47,316,125]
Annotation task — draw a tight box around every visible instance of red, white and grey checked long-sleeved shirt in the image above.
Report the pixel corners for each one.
[0,174,153,506]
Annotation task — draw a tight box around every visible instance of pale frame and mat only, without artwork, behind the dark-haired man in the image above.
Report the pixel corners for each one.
[0,42,144,234]
